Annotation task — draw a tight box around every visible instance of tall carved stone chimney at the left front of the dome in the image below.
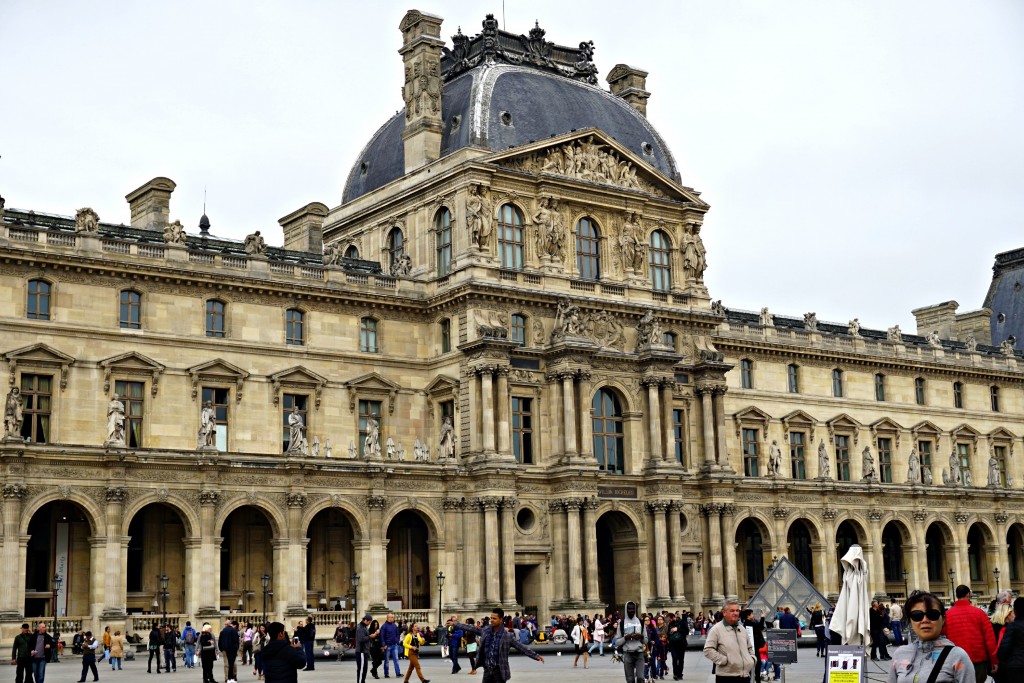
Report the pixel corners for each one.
[398,9,444,173]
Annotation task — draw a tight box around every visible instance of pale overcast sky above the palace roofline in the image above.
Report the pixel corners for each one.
[0,0,1024,332]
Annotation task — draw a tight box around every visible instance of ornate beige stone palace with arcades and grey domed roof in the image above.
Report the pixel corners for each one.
[0,11,1024,638]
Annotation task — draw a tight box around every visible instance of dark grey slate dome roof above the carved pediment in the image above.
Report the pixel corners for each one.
[342,65,680,203]
